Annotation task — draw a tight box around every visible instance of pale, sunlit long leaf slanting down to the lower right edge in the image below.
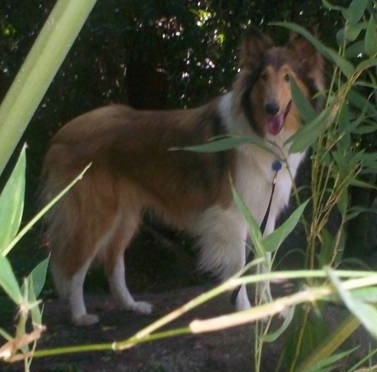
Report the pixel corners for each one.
[326,268,377,338]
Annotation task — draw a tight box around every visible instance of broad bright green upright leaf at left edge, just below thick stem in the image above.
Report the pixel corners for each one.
[0,146,26,255]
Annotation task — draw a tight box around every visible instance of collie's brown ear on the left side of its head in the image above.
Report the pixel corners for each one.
[239,27,273,70]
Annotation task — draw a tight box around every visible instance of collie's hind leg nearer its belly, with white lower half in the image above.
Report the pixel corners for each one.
[103,215,152,314]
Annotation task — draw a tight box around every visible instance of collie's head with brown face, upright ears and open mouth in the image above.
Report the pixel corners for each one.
[235,28,324,138]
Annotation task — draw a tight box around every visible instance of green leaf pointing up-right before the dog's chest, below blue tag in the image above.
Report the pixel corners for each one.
[263,200,309,252]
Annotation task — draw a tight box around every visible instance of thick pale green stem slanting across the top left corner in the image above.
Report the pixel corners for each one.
[0,0,96,174]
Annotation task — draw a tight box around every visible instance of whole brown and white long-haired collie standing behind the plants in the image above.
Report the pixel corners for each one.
[42,29,323,325]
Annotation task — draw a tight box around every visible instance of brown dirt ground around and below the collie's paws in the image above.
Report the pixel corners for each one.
[6,285,372,372]
